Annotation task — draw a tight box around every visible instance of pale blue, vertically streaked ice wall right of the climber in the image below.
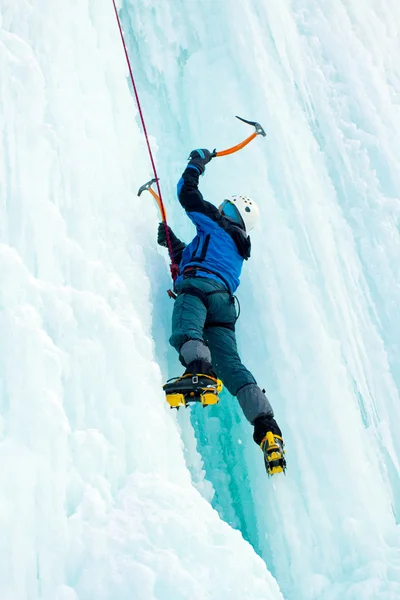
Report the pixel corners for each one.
[123,0,400,600]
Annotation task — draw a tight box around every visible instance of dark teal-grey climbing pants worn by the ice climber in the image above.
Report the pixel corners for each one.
[170,277,274,423]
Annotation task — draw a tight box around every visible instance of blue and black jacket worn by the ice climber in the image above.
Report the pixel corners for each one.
[175,163,251,293]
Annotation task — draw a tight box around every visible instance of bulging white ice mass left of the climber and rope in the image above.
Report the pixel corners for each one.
[0,0,282,600]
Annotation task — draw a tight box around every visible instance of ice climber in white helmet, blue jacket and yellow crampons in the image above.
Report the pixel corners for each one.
[157,149,285,474]
